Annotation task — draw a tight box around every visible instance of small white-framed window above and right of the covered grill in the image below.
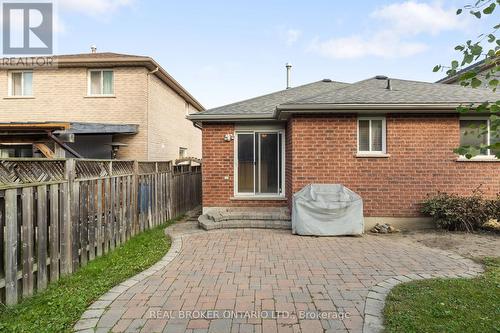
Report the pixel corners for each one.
[358,117,386,154]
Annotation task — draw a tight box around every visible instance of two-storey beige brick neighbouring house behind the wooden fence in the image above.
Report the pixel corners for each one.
[0,53,203,160]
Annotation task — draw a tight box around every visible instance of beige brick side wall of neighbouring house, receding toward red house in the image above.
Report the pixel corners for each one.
[148,75,201,160]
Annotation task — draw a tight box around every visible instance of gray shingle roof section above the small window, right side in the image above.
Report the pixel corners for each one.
[283,78,500,106]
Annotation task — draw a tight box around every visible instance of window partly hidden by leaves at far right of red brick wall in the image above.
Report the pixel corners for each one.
[460,118,500,156]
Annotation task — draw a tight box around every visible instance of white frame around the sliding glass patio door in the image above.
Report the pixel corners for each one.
[233,127,286,200]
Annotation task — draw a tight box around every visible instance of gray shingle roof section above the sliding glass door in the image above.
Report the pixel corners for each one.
[196,80,349,116]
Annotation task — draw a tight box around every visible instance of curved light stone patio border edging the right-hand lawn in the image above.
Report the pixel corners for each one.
[363,248,484,333]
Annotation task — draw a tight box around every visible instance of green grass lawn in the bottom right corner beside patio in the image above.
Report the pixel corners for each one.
[384,258,500,333]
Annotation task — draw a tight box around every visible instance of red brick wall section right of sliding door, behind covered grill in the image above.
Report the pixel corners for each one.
[287,115,500,216]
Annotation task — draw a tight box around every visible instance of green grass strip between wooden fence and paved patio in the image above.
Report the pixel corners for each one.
[0,219,182,333]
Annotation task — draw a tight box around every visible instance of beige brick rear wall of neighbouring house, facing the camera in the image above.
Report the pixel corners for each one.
[0,67,147,159]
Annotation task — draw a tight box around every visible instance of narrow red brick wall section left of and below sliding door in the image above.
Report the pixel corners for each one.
[202,124,287,207]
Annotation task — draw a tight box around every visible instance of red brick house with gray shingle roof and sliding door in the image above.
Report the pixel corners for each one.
[189,76,500,226]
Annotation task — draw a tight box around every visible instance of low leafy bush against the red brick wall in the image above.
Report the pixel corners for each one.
[422,190,500,232]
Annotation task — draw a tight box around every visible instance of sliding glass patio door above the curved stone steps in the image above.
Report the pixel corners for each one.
[235,130,284,195]
